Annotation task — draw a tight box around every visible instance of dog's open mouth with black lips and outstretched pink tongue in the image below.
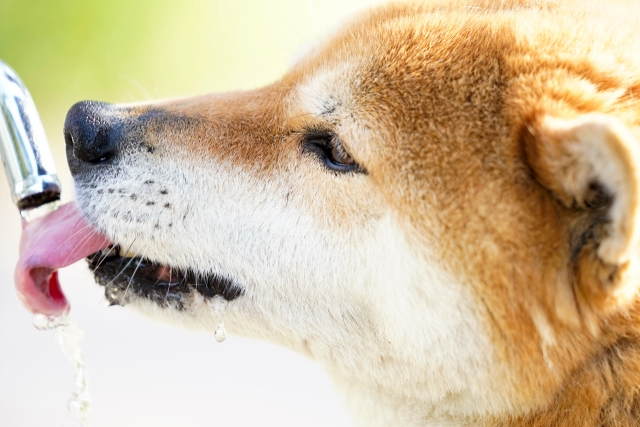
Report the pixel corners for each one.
[15,203,243,316]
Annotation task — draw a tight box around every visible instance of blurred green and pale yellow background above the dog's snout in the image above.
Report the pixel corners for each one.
[0,0,358,187]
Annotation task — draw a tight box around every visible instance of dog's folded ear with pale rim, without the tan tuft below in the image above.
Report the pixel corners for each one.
[525,114,640,265]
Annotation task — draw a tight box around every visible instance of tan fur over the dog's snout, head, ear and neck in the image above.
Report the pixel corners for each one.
[75,0,640,427]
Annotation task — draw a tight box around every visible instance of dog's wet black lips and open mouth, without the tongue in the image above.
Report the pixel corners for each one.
[87,245,242,310]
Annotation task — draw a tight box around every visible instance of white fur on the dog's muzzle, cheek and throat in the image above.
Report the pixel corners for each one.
[78,134,506,425]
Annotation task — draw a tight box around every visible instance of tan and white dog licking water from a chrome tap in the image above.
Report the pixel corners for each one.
[16,0,640,427]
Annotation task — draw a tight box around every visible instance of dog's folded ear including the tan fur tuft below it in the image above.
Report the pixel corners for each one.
[524,114,640,320]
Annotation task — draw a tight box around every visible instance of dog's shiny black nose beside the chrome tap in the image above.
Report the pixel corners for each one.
[64,101,118,166]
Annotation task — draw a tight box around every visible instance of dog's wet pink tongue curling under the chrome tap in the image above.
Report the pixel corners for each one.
[15,202,111,316]
